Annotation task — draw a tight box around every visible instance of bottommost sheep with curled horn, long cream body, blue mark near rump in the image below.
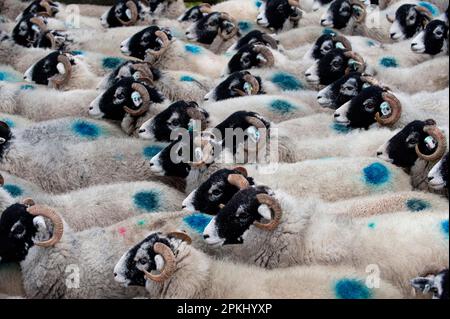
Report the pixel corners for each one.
[114,233,402,299]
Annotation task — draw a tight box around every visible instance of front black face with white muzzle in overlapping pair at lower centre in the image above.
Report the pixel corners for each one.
[203,186,273,245]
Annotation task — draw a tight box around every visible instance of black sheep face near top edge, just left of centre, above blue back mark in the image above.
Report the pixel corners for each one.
[186,12,238,44]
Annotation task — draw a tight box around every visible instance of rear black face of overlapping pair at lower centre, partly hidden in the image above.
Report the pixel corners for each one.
[182,169,254,215]
